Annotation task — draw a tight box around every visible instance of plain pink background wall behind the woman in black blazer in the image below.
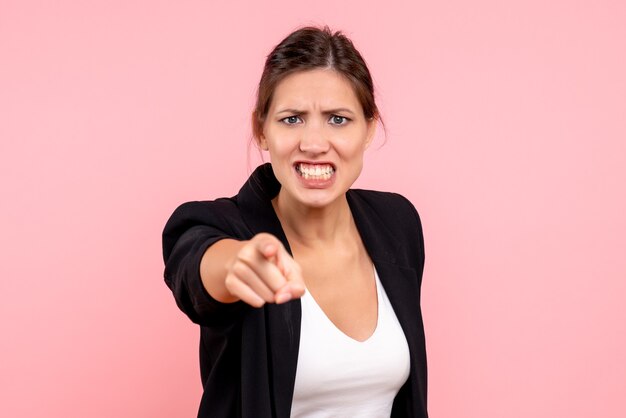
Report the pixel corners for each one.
[0,0,626,418]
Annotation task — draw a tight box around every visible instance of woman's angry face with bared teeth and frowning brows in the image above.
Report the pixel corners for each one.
[259,69,376,208]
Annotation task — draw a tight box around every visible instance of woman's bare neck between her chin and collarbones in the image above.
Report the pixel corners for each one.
[272,193,352,247]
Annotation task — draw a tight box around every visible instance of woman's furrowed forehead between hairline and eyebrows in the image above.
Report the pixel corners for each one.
[270,69,361,111]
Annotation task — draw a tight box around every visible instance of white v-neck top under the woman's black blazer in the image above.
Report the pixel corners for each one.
[291,270,410,418]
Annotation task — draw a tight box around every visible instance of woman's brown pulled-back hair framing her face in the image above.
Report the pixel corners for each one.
[252,26,384,140]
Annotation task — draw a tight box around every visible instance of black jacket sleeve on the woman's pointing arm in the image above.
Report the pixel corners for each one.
[163,199,250,326]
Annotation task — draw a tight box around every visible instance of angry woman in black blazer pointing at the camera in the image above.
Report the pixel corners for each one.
[163,27,427,418]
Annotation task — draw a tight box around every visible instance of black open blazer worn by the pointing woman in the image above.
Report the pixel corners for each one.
[163,164,428,418]
